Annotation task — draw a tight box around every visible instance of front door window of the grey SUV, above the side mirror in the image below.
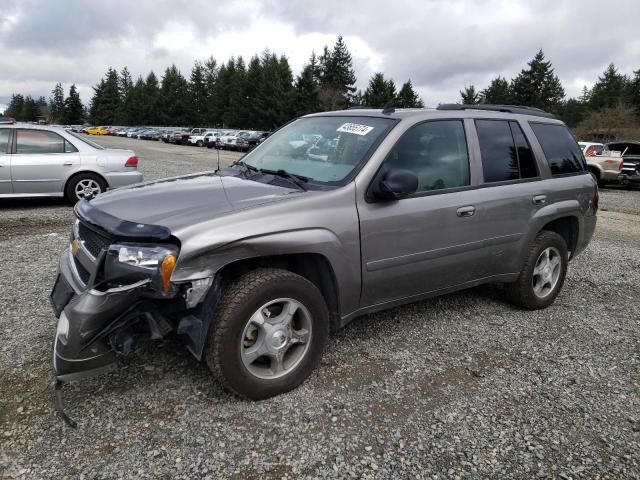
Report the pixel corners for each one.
[384,120,469,192]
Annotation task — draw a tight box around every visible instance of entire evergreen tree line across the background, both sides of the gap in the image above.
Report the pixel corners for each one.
[5,41,640,134]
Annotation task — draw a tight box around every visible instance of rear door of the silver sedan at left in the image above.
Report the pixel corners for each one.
[11,128,80,193]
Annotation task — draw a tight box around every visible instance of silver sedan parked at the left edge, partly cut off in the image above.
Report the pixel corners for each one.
[0,124,142,203]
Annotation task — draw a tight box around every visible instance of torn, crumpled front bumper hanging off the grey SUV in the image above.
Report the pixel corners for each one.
[50,249,220,382]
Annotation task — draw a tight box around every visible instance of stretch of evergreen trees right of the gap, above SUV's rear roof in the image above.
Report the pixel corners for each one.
[460,50,640,132]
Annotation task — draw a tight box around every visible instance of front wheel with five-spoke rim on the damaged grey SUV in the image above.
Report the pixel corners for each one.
[205,268,329,400]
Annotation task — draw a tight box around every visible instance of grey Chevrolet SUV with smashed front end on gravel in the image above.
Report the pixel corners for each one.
[51,105,598,399]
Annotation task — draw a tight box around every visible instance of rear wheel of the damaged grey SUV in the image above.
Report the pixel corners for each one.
[506,230,568,310]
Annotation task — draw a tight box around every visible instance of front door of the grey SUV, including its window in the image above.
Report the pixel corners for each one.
[358,120,489,306]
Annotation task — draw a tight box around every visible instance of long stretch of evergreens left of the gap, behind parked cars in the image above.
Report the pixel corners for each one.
[5,36,423,130]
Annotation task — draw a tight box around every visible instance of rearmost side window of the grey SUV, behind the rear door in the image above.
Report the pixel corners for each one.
[529,122,587,175]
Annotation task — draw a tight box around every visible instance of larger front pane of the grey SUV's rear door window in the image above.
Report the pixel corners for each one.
[476,120,520,183]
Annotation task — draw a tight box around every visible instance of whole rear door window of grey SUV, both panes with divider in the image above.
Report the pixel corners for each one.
[475,120,538,183]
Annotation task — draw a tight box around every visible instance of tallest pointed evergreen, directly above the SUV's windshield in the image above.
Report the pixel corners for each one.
[319,35,356,110]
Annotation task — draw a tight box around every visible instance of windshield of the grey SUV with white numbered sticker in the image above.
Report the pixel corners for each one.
[243,116,396,184]
